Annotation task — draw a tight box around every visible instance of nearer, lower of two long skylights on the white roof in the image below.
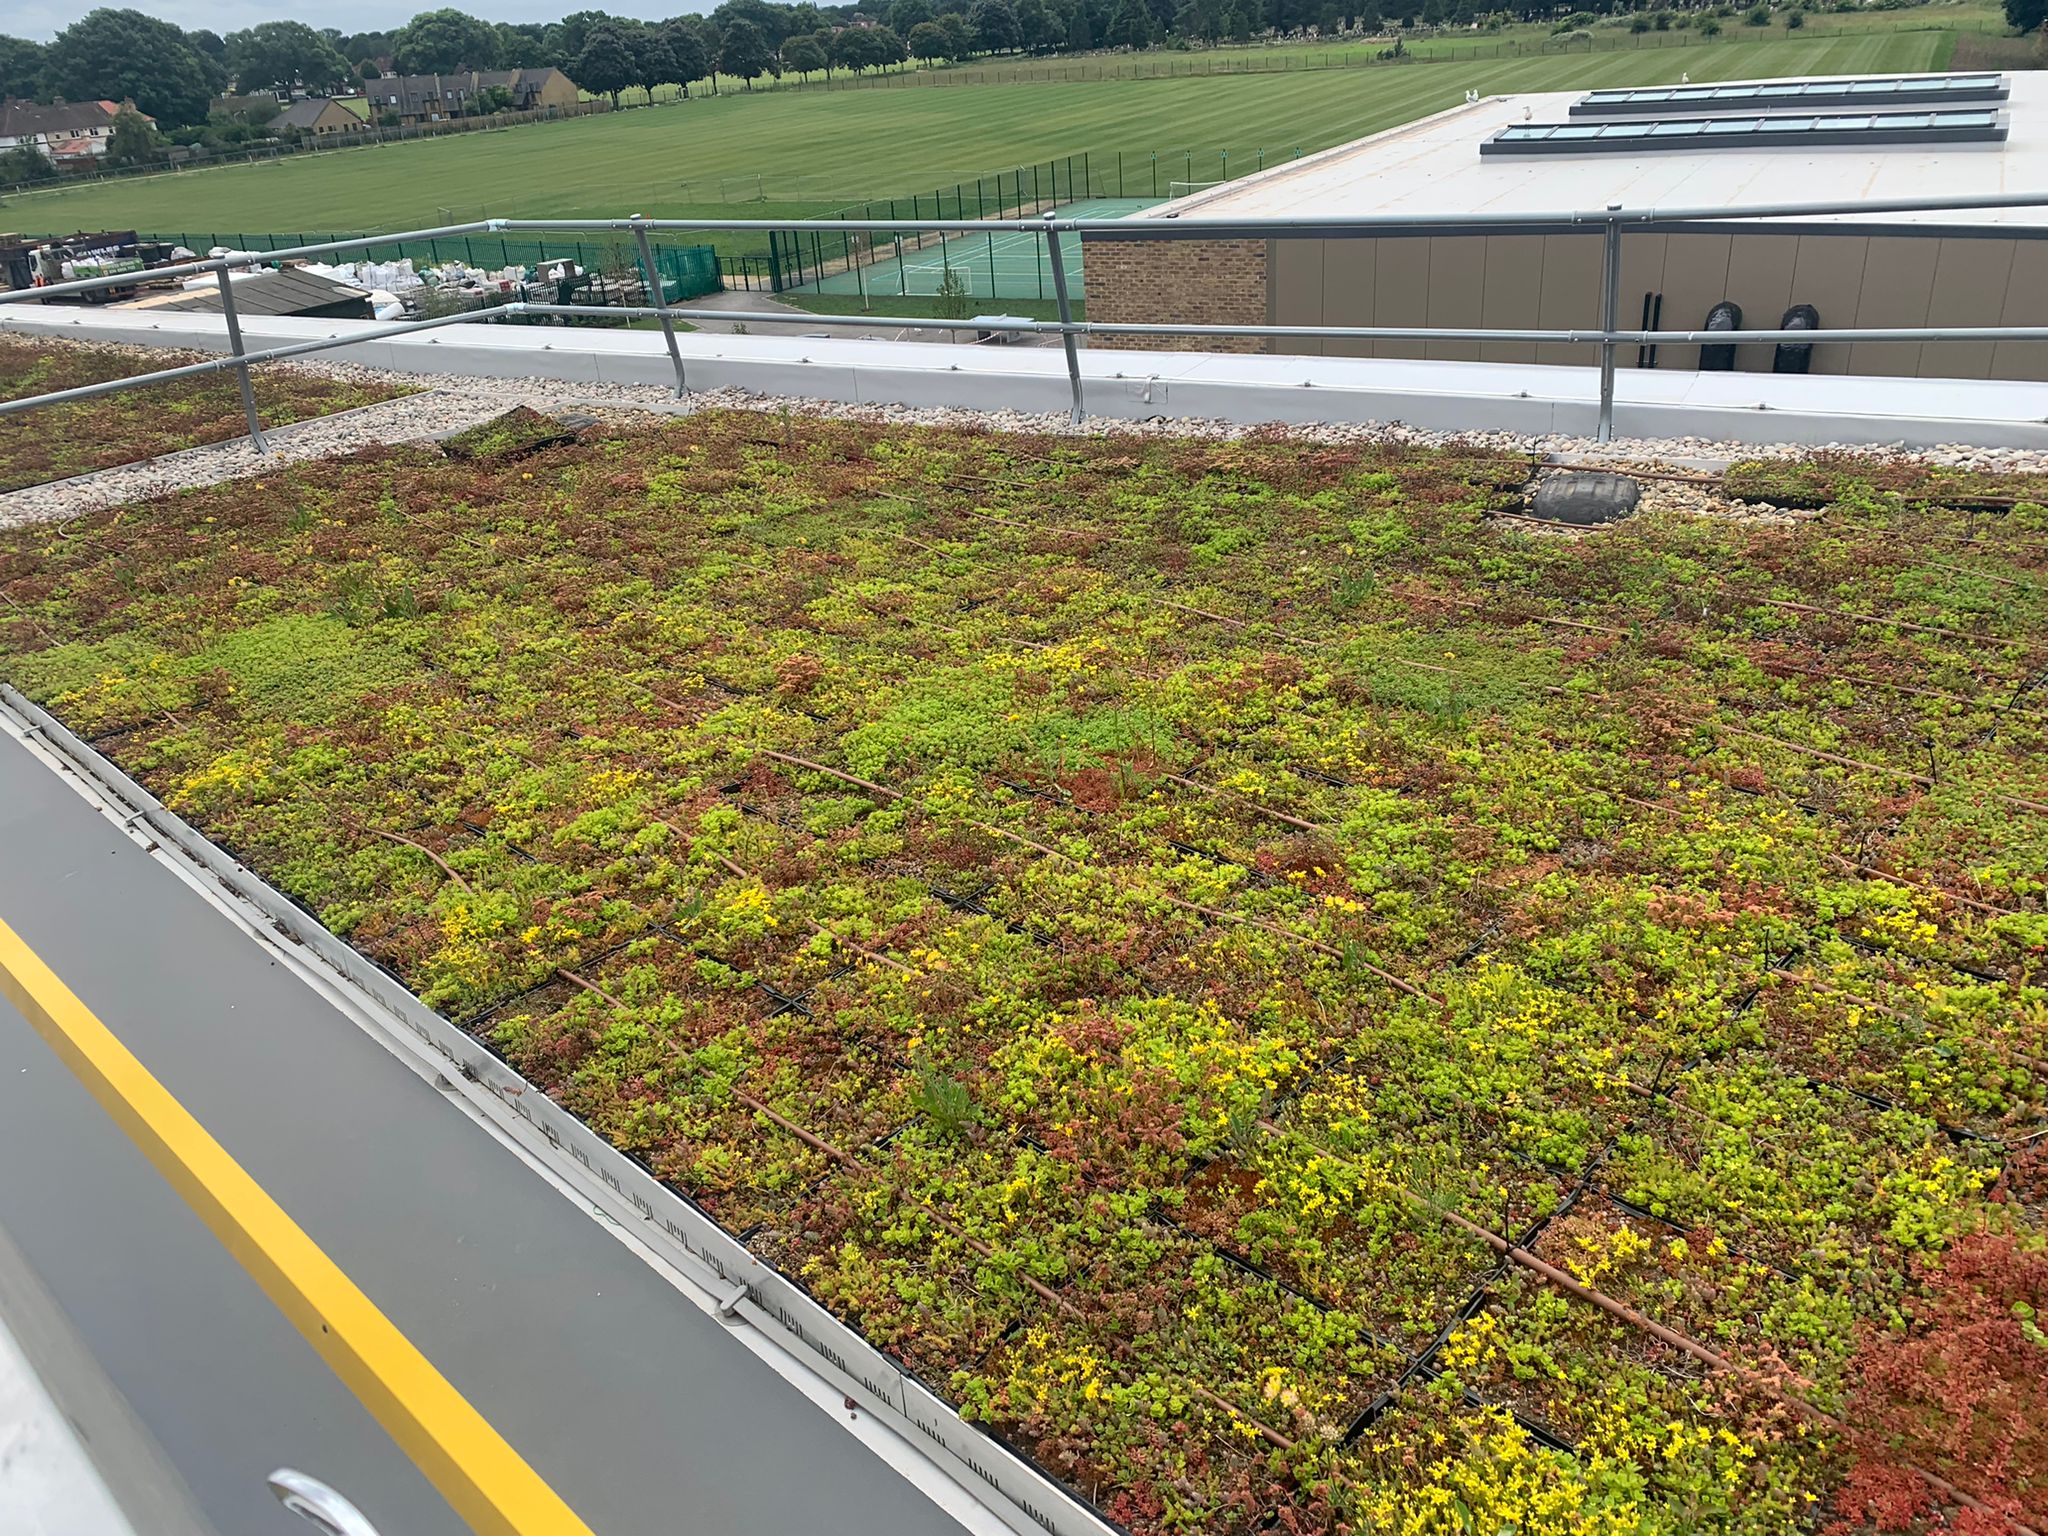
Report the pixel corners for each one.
[1479,106,2007,156]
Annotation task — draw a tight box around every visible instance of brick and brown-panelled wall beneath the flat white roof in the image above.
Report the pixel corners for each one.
[1114,221,2048,379]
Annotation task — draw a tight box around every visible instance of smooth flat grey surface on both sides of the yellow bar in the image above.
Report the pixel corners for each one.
[0,733,961,1536]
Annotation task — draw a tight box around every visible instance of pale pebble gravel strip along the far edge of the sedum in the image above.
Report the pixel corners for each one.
[0,340,2048,526]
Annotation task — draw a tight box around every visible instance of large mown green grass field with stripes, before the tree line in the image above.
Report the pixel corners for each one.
[0,31,1954,250]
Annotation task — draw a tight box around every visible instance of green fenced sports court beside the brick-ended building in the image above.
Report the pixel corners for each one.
[795,197,1161,299]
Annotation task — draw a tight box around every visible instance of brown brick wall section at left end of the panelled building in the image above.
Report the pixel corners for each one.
[1081,240,1266,352]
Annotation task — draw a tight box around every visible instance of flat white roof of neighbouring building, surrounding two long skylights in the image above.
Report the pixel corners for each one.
[1133,63,2048,225]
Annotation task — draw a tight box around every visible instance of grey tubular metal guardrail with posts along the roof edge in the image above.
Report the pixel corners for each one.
[0,190,2048,446]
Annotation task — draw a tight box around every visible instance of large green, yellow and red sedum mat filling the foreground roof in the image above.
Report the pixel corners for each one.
[0,414,2048,1534]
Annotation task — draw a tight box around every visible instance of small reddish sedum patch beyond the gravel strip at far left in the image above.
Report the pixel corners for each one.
[0,338,410,496]
